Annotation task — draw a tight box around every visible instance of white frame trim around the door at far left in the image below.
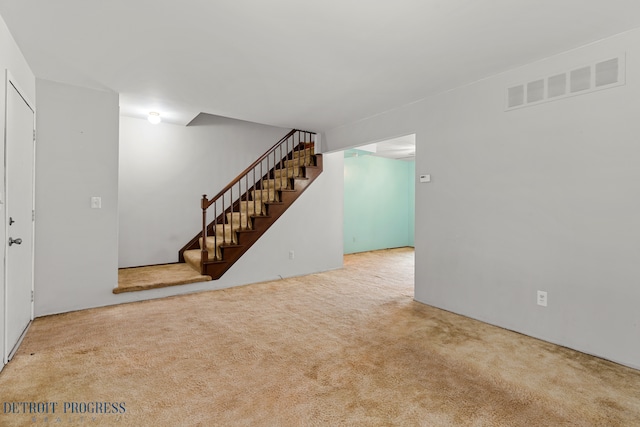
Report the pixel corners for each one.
[0,69,36,364]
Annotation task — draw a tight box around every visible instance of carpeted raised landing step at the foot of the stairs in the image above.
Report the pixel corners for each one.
[113,263,211,294]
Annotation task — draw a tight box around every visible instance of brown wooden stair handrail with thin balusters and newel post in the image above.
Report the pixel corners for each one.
[200,129,315,274]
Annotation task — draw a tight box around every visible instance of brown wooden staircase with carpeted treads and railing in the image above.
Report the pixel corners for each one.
[179,129,322,280]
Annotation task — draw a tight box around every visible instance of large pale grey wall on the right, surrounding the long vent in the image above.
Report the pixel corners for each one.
[324,30,640,368]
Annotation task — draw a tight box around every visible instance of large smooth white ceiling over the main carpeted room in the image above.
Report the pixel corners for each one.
[0,0,640,131]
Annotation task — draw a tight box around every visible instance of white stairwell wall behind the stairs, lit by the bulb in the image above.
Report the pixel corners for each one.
[119,115,289,267]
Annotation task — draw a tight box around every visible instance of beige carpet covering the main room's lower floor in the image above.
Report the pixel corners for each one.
[0,249,640,426]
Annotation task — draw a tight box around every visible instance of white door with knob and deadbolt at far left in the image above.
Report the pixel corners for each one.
[4,79,35,360]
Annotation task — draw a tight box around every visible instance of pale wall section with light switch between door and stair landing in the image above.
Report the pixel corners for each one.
[35,79,118,316]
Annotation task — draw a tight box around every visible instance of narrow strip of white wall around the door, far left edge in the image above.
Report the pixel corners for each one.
[0,17,36,370]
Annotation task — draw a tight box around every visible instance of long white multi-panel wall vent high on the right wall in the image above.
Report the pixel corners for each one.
[506,54,626,111]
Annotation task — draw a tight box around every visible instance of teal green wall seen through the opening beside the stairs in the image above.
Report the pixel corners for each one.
[344,150,415,254]
